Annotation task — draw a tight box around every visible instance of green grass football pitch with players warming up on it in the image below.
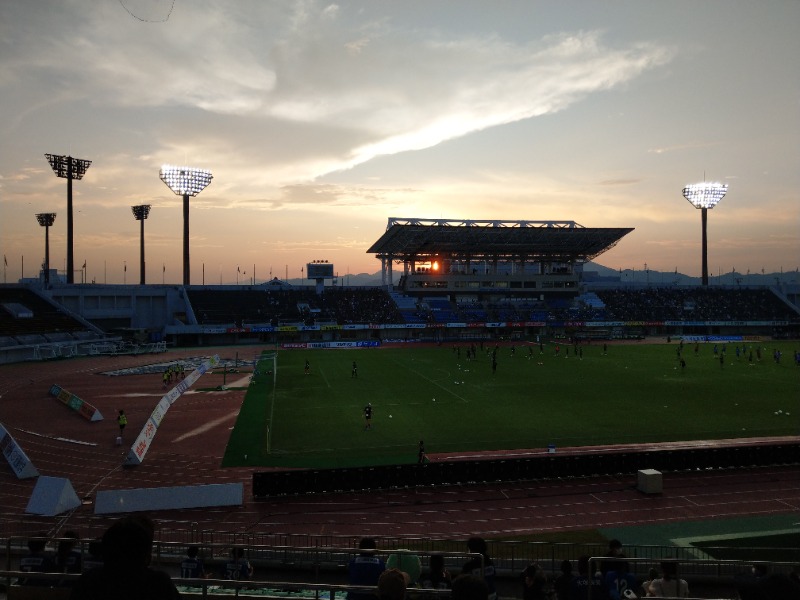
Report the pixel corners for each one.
[223,342,800,468]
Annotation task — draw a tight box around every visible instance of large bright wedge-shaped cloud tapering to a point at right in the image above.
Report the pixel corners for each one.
[0,1,674,190]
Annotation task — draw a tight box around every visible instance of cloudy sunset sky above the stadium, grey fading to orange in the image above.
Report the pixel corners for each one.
[0,0,800,284]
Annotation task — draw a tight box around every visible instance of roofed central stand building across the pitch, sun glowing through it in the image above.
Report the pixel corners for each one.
[367,217,633,303]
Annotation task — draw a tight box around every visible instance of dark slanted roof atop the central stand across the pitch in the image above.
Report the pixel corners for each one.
[367,217,633,262]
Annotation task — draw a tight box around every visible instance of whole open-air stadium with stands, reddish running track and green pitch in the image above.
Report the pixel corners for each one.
[0,218,800,597]
